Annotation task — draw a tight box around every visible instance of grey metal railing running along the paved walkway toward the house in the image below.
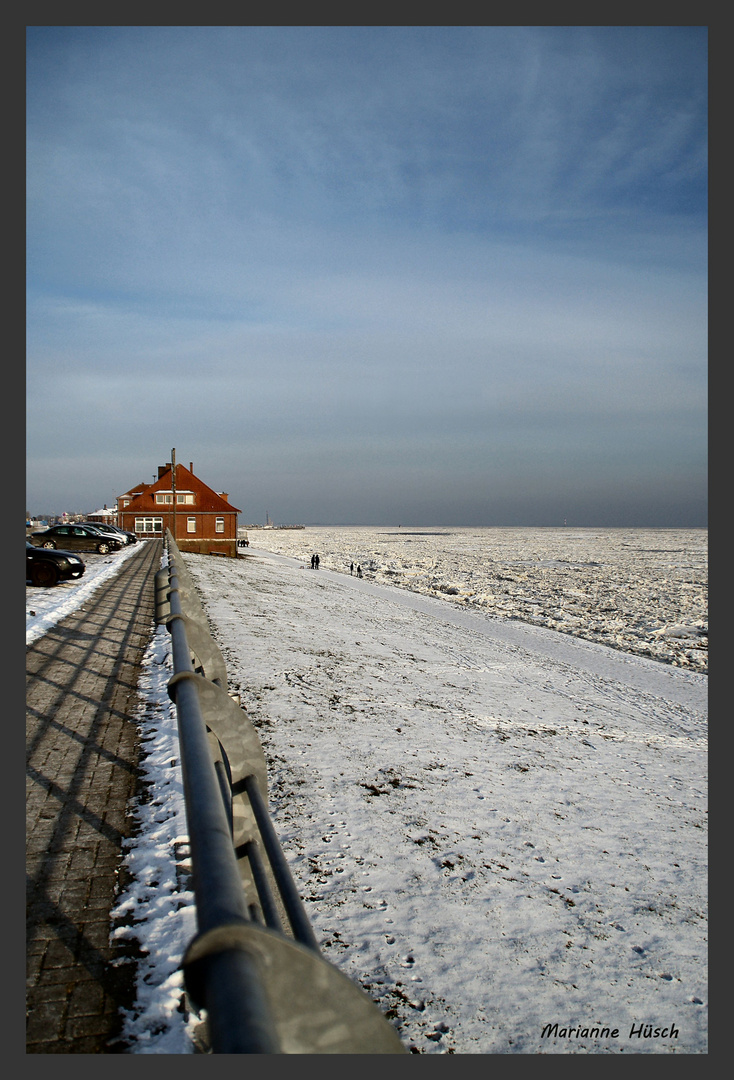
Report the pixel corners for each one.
[155,530,407,1054]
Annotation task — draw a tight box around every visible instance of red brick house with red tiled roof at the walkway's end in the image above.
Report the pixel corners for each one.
[118,461,240,557]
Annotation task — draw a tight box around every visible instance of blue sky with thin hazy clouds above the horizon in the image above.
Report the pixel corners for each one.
[26,26,707,526]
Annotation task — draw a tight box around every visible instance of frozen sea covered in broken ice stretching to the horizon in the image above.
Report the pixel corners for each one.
[241,526,708,672]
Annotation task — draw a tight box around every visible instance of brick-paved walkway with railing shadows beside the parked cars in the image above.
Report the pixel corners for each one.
[26,540,162,1054]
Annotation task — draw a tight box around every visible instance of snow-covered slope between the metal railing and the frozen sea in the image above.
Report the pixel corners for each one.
[187,534,707,1054]
